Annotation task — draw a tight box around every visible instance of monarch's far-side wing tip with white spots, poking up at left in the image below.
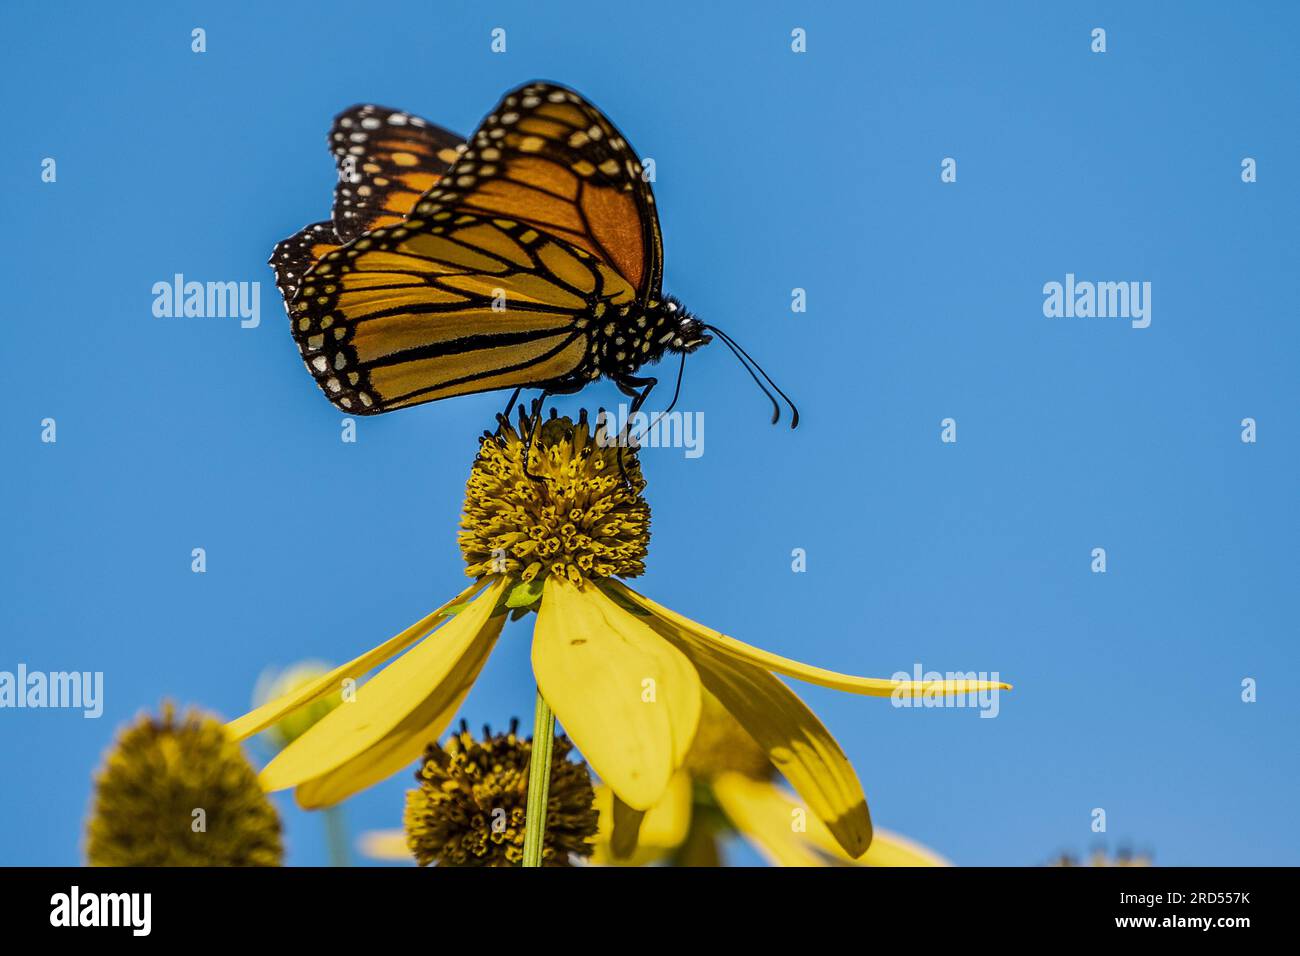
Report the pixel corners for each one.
[329,104,464,242]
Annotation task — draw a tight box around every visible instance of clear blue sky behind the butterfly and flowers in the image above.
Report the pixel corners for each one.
[0,3,1300,865]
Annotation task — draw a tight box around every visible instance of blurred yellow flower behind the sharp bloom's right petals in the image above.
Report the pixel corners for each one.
[593,692,948,866]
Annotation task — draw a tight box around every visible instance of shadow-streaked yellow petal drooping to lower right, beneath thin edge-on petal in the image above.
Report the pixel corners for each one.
[624,590,871,857]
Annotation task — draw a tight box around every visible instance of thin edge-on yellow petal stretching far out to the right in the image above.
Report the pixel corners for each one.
[603,578,1011,697]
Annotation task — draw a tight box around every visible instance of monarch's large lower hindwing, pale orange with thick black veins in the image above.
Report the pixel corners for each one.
[290,213,636,415]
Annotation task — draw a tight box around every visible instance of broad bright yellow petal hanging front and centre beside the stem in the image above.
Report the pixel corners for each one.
[533,575,699,810]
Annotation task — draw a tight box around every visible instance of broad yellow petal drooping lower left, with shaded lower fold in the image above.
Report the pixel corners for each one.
[260,580,506,791]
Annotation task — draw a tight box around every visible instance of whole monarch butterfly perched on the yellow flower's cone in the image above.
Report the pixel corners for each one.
[270,82,798,427]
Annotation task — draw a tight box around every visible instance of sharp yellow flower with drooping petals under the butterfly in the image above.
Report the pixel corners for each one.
[230,412,1008,857]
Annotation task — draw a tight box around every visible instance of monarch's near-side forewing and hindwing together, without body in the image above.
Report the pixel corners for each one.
[290,83,663,415]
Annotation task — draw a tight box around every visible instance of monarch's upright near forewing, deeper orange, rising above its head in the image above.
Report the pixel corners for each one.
[405,82,663,303]
